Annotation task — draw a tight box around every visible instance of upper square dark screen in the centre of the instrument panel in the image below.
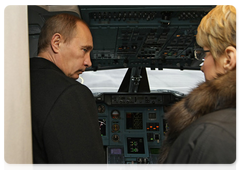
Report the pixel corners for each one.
[126,112,143,129]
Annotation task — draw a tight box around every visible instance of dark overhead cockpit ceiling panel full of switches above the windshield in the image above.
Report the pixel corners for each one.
[29,0,220,70]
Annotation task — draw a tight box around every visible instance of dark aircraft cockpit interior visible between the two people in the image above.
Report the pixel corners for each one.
[28,0,219,170]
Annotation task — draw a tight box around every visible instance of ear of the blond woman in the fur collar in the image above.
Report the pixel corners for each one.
[223,46,239,71]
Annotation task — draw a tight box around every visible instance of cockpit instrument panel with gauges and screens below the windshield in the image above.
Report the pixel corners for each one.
[95,92,183,170]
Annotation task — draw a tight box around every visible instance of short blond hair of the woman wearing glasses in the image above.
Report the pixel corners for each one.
[196,0,240,59]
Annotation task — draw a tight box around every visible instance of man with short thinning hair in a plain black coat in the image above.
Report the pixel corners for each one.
[30,14,106,170]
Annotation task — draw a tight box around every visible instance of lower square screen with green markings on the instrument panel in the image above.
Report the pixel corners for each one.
[127,137,145,154]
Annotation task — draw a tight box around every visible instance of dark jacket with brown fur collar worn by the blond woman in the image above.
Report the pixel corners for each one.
[159,69,240,170]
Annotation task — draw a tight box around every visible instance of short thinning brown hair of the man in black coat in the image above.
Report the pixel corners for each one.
[38,13,87,53]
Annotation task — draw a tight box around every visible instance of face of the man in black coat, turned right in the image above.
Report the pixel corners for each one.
[59,22,93,79]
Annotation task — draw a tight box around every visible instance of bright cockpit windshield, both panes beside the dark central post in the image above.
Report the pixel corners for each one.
[78,68,204,94]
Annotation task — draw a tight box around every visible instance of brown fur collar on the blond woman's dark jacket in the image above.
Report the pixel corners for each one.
[159,69,240,170]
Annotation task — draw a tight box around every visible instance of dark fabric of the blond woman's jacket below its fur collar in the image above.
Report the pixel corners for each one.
[162,109,240,170]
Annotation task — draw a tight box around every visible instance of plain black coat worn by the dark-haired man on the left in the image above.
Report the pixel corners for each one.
[30,58,106,170]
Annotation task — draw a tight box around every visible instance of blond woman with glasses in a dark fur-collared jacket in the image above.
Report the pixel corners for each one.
[159,0,240,170]
